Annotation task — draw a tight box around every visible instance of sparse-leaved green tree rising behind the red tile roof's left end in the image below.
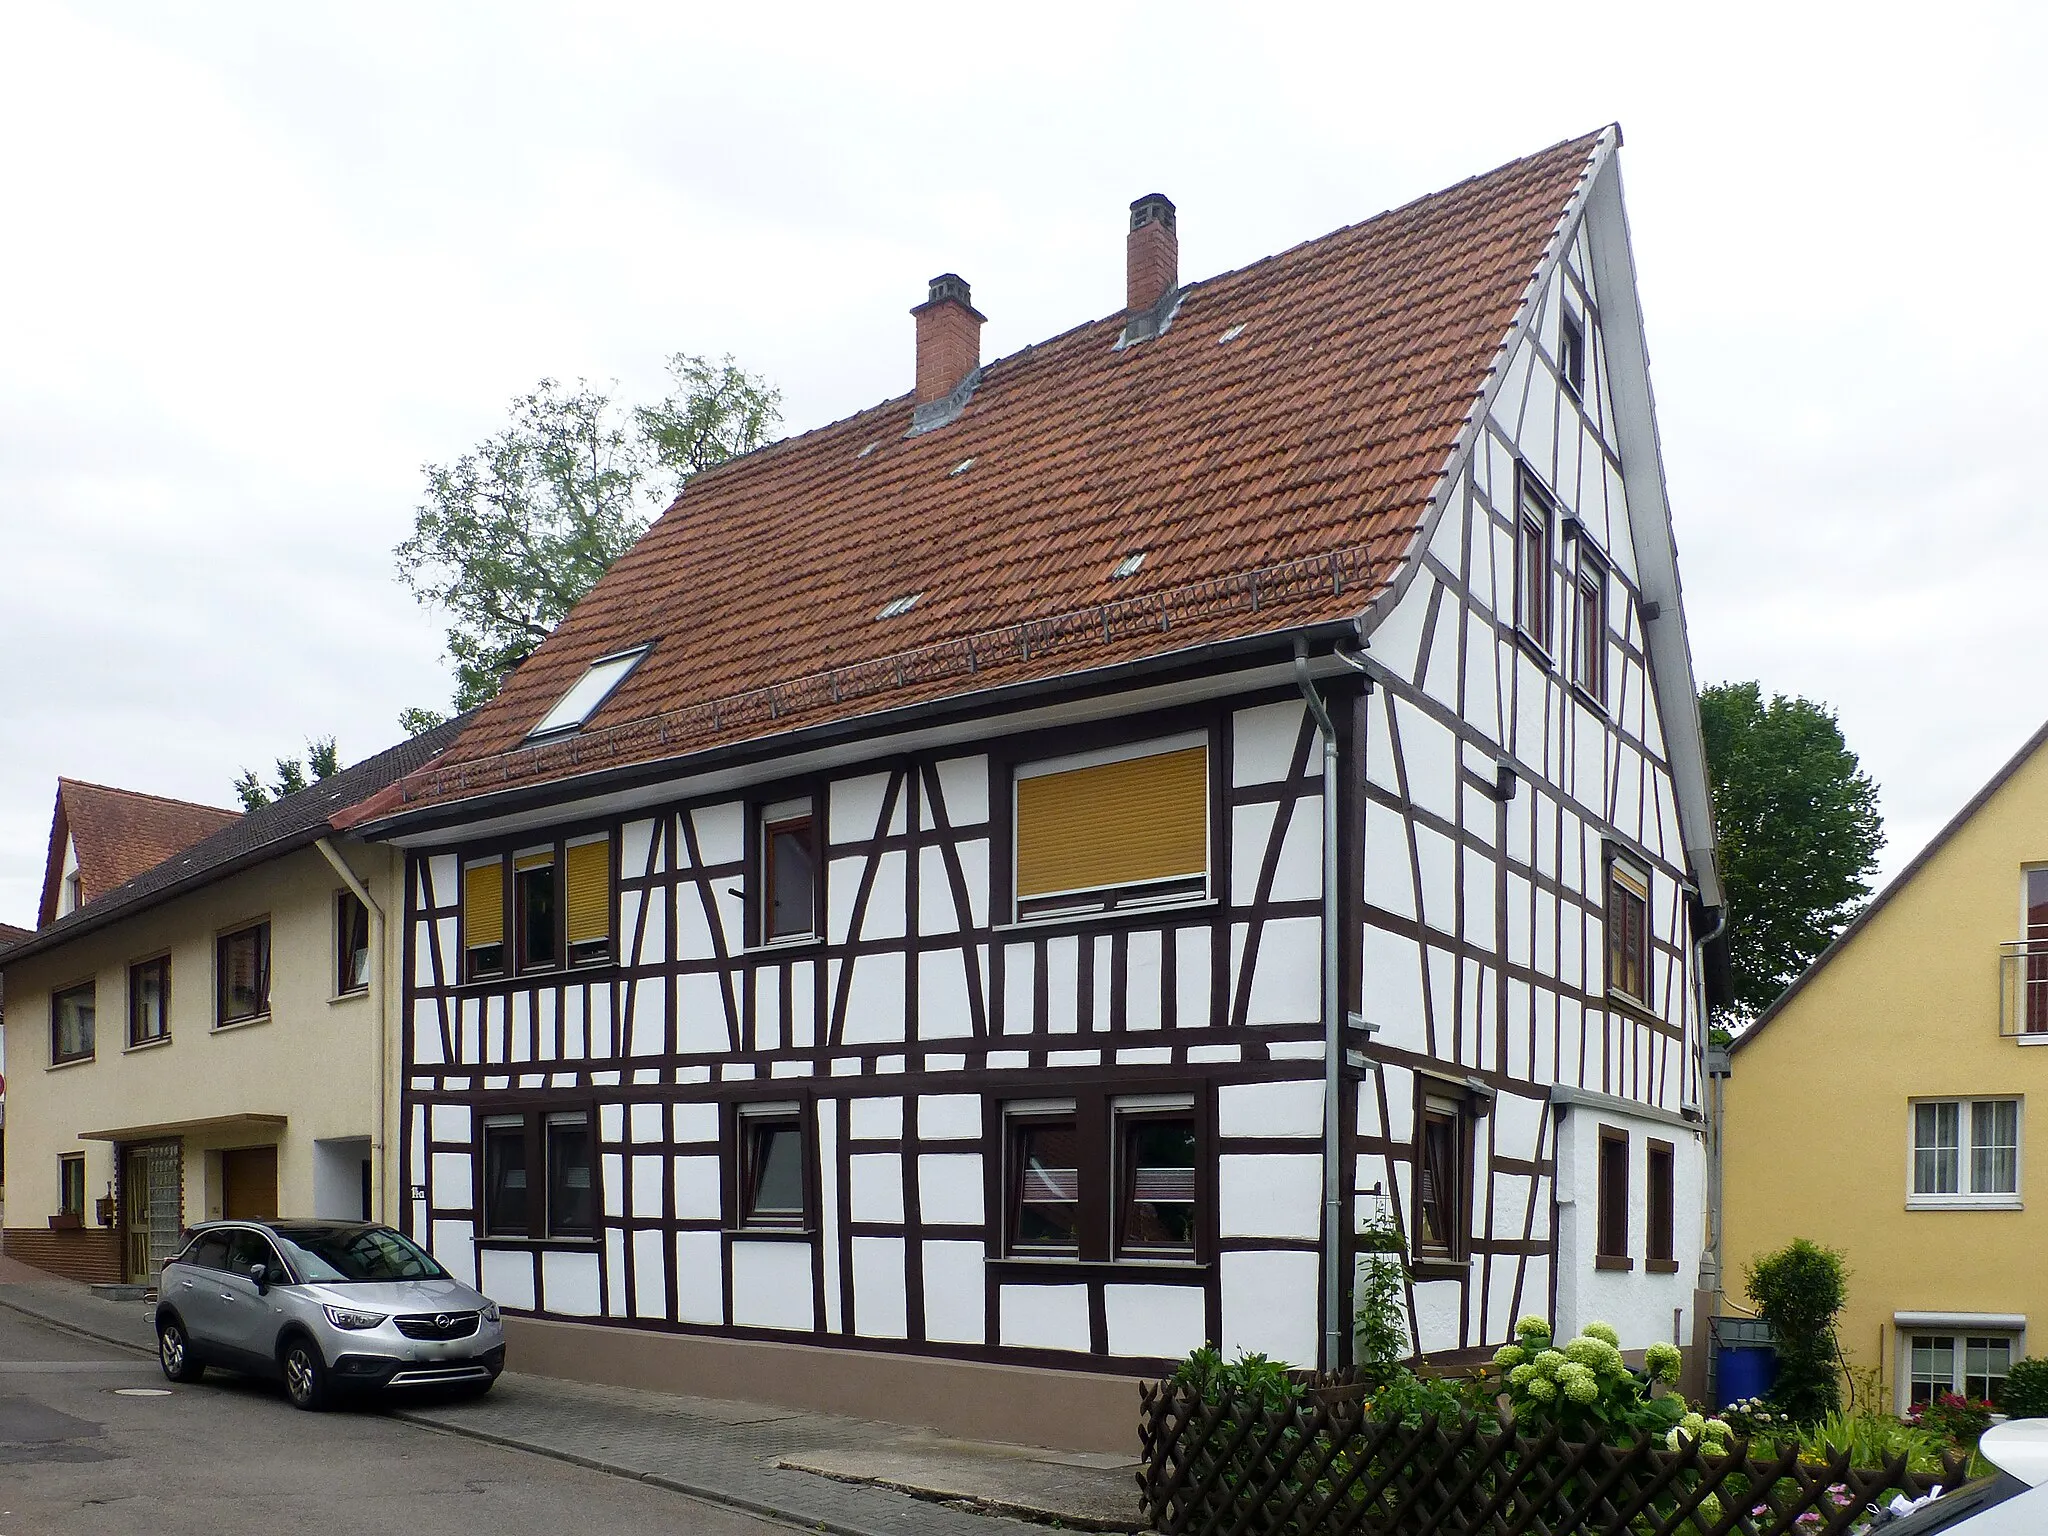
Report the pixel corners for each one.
[395,352,782,720]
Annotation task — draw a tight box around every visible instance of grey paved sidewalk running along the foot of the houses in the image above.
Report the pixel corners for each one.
[0,1260,1139,1536]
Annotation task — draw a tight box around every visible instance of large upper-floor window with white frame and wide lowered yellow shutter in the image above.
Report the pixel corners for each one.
[1014,733,1208,918]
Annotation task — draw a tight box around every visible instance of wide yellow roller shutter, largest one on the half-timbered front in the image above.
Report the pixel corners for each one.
[1018,748,1208,897]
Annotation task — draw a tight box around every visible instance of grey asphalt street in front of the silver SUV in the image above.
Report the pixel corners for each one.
[0,1311,791,1536]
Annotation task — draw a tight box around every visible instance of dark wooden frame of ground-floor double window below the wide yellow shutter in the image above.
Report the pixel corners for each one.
[987,1079,1217,1274]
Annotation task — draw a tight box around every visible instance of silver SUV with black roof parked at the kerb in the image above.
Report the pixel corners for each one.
[156,1221,506,1409]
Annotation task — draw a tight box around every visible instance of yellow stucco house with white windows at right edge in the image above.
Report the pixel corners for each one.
[1722,727,2048,1411]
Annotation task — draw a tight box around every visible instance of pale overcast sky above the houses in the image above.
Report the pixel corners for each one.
[0,0,2048,924]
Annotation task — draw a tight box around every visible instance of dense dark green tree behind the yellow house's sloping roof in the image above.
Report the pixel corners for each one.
[1700,682,1884,1020]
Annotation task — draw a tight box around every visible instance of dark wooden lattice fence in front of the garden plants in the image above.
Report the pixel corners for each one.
[1139,1382,1966,1536]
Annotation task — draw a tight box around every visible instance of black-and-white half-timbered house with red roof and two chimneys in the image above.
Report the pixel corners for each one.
[367,129,1720,1442]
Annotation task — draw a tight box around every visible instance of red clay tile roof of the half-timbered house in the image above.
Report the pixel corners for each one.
[403,129,1612,809]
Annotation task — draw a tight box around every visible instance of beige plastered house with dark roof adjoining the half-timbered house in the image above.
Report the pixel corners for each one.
[0,725,457,1280]
